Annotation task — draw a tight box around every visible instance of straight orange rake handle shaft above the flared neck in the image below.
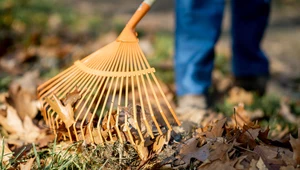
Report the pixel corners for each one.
[126,0,155,30]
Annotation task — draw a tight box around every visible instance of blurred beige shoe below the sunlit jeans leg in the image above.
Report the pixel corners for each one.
[176,95,207,131]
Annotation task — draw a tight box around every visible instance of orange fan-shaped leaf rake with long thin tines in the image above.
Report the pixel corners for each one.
[38,0,180,144]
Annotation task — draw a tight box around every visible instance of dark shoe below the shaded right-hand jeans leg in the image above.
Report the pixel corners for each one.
[234,76,269,96]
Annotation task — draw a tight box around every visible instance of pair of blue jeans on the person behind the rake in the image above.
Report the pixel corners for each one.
[175,0,270,96]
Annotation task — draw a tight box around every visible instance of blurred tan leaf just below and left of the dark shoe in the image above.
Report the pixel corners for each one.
[227,87,253,105]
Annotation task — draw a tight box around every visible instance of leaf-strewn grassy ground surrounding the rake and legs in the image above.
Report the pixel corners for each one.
[0,0,300,169]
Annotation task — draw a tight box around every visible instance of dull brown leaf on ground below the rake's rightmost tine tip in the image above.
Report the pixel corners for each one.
[179,138,210,163]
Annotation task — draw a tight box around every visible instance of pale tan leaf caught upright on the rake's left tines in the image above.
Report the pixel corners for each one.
[45,94,75,129]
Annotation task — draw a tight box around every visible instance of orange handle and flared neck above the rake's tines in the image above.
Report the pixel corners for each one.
[117,0,154,42]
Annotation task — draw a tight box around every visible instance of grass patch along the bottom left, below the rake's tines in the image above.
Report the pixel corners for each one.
[0,139,140,170]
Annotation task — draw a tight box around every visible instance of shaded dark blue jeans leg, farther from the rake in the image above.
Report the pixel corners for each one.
[231,0,270,81]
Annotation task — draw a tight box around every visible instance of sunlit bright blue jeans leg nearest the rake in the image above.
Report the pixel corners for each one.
[175,0,225,96]
